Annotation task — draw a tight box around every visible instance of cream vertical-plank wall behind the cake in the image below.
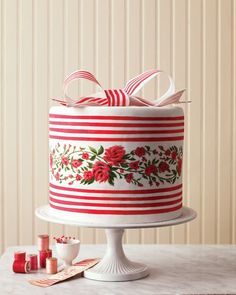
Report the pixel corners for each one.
[0,0,236,251]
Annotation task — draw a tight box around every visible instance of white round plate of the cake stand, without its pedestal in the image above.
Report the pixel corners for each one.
[35,205,197,229]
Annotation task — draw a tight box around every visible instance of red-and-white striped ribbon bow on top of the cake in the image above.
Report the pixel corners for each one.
[54,70,185,107]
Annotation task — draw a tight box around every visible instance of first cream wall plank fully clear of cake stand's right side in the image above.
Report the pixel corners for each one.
[202,0,217,244]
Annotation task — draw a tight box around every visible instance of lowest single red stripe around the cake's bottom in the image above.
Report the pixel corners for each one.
[50,203,182,215]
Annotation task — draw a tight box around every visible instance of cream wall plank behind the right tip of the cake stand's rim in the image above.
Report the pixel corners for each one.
[187,1,203,243]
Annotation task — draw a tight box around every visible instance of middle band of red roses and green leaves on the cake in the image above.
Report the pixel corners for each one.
[50,143,183,187]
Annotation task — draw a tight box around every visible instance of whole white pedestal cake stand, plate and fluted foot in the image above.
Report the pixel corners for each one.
[35,205,197,281]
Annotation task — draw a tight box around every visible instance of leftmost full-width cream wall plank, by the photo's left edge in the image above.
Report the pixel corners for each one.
[3,0,19,250]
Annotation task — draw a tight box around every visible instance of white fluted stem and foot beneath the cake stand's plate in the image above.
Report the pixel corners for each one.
[84,229,149,282]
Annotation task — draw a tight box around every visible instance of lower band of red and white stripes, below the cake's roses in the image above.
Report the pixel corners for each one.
[49,183,182,215]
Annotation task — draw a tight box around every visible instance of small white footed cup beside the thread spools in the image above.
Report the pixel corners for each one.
[56,239,80,267]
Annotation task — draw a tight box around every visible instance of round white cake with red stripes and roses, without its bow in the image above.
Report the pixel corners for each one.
[49,106,184,224]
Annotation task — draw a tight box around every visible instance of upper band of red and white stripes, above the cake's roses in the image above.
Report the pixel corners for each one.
[49,114,184,142]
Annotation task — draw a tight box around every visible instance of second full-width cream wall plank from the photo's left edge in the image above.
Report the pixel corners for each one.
[17,0,34,245]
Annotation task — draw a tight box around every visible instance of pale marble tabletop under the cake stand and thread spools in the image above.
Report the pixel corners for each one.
[0,245,236,295]
